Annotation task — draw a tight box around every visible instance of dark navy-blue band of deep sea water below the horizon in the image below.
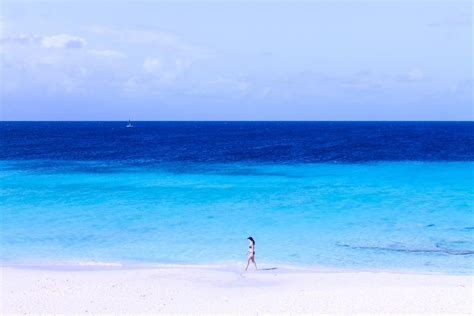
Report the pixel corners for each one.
[0,122,474,164]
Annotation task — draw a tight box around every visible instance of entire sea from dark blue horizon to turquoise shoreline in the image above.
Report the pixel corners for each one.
[0,122,474,274]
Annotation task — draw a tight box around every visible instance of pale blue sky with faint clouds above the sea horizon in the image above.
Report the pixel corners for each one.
[0,0,474,121]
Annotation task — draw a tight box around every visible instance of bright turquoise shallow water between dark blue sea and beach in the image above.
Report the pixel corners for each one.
[0,160,474,273]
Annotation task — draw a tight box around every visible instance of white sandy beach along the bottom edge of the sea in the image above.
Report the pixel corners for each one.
[0,267,473,314]
